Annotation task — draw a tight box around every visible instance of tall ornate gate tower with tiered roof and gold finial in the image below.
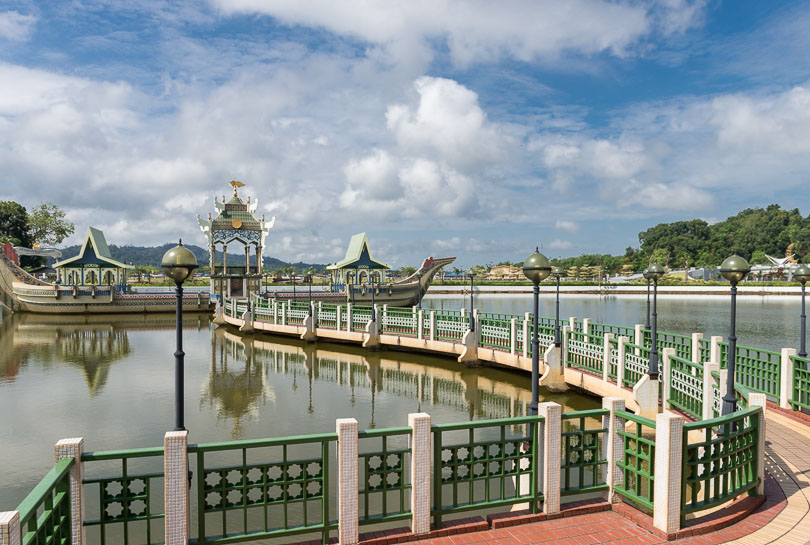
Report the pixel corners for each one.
[197,180,276,297]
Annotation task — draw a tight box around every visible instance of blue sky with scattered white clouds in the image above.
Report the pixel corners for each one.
[0,0,810,267]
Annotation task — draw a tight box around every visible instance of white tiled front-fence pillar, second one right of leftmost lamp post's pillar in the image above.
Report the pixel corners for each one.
[408,413,433,536]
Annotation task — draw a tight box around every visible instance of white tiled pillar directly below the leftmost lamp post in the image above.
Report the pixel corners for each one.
[163,430,189,545]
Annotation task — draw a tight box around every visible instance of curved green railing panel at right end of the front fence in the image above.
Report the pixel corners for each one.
[681,407,762,525]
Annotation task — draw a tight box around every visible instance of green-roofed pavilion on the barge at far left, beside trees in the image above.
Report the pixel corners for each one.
[53,227,135,287]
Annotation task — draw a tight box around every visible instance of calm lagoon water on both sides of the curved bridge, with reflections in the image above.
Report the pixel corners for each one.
[0,295,799,510]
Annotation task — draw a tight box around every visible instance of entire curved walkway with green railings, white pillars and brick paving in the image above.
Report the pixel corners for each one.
[0,299,810,545]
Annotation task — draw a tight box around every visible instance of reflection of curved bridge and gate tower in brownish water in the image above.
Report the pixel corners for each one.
[211,328,599,438]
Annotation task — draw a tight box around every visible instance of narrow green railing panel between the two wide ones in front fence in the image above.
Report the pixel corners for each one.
[358,427,411,524]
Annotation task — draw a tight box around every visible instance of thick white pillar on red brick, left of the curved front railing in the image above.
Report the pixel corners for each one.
[653,413,683,533]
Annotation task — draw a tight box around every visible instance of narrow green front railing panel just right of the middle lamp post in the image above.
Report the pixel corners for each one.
[560,409,610,496]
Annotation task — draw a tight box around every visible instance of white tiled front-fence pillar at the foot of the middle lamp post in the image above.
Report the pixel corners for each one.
[537,401,562,515]
